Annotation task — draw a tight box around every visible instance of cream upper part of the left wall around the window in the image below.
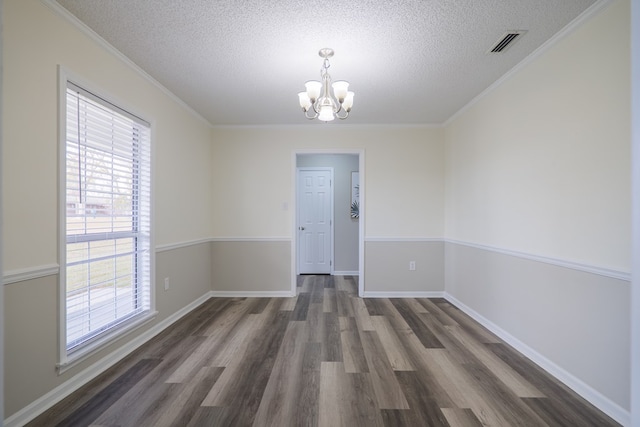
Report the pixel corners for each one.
[2,0,212,271]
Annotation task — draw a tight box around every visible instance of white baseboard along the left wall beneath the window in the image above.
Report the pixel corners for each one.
[4,292,211,427]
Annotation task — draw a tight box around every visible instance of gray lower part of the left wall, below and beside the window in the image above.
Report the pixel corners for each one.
[0,242,211,424]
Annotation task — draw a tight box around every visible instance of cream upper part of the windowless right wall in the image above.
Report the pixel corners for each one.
[446,0,631,271]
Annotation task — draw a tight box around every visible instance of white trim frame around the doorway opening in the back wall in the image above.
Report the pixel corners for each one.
[290,148,367,297]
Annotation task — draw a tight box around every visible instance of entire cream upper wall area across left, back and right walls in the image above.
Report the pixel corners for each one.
[2,0,630,270]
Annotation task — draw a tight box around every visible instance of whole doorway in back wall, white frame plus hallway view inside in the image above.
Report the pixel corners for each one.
[291,150,365,295]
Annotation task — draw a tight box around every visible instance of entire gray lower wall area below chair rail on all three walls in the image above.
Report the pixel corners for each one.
[4,241,630,422]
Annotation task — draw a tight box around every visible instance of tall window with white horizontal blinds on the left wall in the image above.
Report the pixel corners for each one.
[60,81,152,364]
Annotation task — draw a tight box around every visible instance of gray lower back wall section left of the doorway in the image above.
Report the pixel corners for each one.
[211,240,292,293]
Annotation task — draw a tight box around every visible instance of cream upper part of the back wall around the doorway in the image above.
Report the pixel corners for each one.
[211,125,444,238]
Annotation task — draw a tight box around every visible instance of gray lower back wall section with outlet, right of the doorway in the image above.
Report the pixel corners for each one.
[364,240,444,296]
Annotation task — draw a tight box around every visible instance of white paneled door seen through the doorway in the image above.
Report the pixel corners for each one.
[297,168,333,274]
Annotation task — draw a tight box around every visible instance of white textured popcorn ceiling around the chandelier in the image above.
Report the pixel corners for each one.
[57,0,603,125]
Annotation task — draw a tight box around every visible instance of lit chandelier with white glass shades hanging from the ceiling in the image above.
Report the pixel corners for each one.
[298,48,353,122]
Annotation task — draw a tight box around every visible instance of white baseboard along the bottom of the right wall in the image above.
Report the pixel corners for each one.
[444,293,631,426]
